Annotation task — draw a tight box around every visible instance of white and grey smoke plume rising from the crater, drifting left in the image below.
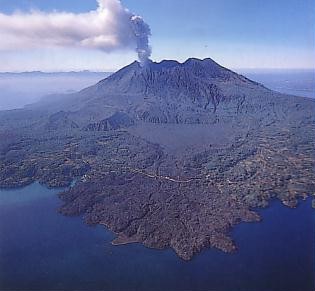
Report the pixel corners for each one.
[0,0,151,64]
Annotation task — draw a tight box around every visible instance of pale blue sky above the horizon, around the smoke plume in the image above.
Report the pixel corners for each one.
[0,0,315,72]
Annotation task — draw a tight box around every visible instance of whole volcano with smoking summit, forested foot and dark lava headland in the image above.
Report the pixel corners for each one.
[0,58,315,260]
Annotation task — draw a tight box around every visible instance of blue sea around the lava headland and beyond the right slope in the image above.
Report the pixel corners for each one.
[0,72,315,291]
